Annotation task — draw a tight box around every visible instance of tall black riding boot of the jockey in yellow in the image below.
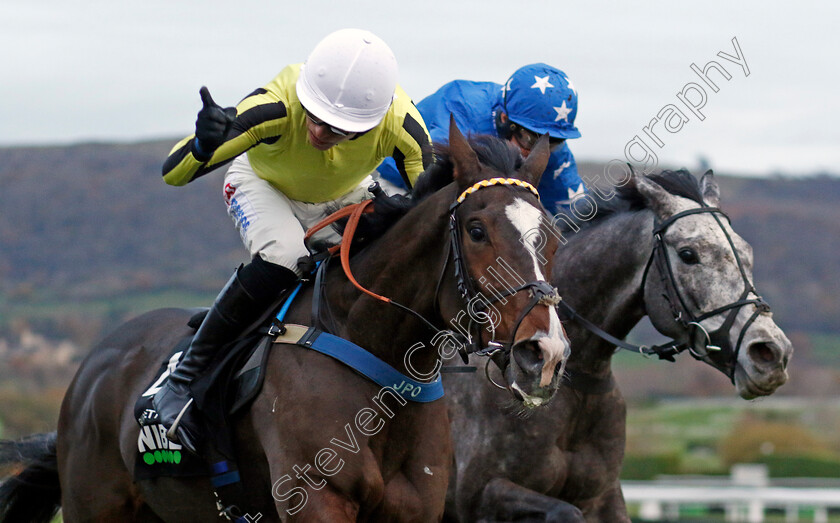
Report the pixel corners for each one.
[152,257,297,452]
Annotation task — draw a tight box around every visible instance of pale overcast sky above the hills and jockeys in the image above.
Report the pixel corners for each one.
[0,0,840,178]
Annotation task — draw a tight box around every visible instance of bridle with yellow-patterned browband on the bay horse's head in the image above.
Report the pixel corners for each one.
[442,178,560,363]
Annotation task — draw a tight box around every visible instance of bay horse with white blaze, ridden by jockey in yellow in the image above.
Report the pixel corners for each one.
[0,119,569,523]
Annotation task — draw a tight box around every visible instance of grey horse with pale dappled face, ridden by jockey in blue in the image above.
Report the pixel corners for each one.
[444,171,793,523]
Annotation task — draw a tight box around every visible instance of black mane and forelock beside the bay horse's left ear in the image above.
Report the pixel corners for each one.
[412,134,522,201]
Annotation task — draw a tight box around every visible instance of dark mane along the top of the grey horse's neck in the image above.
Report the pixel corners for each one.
[556,169,703,231]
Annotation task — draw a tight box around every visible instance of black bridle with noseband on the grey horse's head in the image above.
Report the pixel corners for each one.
[642,206,770,382]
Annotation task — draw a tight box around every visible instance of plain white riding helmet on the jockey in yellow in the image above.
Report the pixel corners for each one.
[295,29,397,132]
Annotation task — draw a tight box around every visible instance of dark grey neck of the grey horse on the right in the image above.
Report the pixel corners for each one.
[553,211,653,375]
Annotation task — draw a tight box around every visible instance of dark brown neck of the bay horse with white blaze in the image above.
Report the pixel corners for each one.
[326,202,448,374]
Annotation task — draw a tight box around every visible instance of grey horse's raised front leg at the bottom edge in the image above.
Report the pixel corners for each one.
[478,478,586,523]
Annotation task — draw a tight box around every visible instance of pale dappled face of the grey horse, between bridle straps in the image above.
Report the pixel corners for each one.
[652,198,793,399]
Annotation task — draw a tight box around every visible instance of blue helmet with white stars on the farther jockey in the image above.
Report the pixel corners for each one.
[502,63,580,139]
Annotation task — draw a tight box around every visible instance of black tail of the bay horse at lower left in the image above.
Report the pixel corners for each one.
[0,432,61,523]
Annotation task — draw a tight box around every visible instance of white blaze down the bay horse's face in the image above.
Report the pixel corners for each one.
[505,198,570,390]
